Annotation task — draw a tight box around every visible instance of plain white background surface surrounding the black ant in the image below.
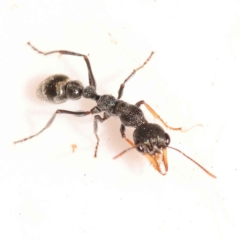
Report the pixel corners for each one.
[0,0,240,240]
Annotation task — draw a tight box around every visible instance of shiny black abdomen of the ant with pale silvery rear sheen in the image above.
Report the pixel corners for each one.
[37,74,84,103]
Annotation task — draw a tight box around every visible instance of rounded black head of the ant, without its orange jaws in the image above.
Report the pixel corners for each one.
[133,123,170,156]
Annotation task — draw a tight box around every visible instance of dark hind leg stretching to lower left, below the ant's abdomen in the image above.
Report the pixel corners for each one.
[14,109,92,144]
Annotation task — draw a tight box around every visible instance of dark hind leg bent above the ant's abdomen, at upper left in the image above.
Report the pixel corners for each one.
[27,42,97,88]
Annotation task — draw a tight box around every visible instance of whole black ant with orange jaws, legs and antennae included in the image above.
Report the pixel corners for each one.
[14,42,216,178]
